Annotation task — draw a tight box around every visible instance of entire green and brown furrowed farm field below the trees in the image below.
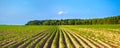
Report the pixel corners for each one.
[0,25,120,48]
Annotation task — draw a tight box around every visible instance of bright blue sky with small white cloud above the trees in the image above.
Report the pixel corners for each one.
[0,0,120,25]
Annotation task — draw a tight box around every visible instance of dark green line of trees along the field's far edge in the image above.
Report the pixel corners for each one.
[26,15,120,25]
